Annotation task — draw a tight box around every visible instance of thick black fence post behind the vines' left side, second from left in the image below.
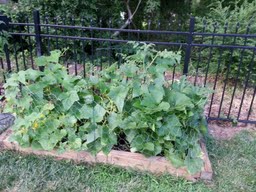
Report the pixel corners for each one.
[33,10,44,71]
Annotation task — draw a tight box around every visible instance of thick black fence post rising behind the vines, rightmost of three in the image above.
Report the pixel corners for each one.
[183,17,195,75]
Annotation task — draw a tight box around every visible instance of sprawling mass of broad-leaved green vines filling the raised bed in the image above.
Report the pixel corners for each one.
[4,43,208,173]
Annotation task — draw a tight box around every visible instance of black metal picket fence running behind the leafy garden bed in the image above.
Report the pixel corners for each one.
[0,11,256,124]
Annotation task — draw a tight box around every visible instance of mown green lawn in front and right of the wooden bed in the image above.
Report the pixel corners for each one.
[0,133,256,192]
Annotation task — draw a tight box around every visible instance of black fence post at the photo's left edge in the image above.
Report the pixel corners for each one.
[0,15,12,72]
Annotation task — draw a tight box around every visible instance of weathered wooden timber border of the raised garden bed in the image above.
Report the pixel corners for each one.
[0,129,213,181]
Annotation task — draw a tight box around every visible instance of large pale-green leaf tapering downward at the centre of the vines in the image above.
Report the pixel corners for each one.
[108,85,129,112]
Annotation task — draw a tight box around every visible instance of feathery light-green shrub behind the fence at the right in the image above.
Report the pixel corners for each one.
[196,0,256,86]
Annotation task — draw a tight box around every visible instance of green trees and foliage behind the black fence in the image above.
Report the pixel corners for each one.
[0,0,256,84]
